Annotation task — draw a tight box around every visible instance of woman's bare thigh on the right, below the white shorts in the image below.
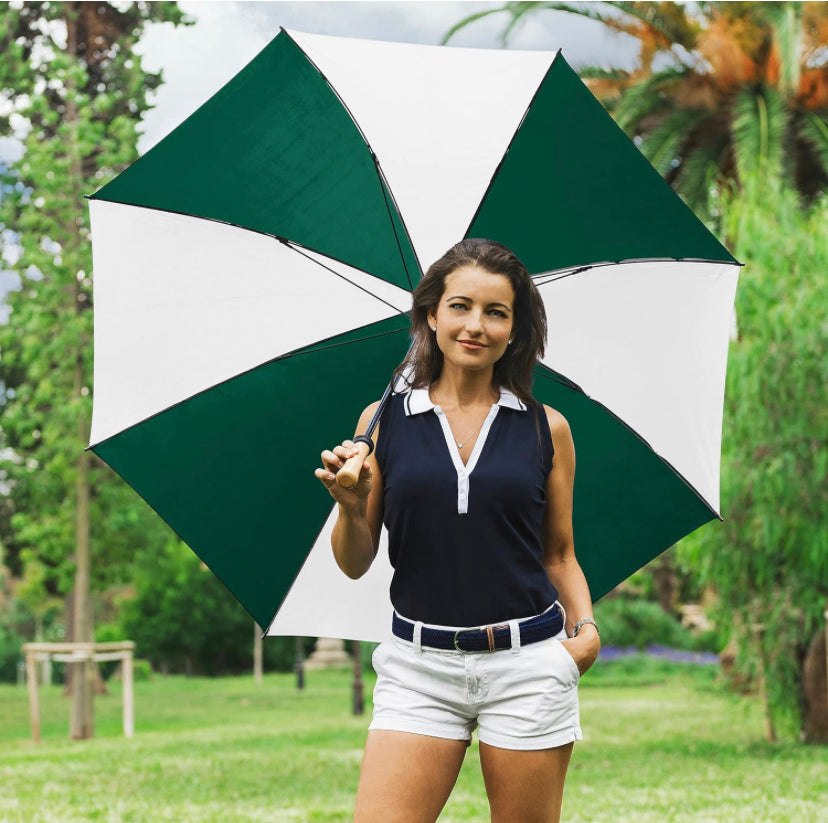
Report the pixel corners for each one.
[480,743,574,823]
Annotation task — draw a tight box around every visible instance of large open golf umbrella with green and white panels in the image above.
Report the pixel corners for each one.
[90,31,738,639]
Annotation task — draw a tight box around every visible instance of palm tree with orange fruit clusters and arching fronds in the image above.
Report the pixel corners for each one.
[445,2,828,213]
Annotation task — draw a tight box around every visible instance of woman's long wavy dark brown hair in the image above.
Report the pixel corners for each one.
[396,238,546,406]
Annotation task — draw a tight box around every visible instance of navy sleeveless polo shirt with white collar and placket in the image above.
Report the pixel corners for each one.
[376,389,558,626]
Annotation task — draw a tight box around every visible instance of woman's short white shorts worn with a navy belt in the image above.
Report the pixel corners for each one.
[369,620,583,751]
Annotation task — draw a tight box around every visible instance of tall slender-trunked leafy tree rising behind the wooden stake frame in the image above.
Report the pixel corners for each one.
[0,2,184,738]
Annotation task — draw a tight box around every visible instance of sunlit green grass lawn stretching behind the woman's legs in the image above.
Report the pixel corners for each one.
[0,660,828,823]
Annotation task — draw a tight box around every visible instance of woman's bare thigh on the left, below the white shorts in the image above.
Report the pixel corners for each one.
[354,729,467,823]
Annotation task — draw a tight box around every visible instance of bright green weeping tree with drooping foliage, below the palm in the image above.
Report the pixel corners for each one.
[679,182,828,738]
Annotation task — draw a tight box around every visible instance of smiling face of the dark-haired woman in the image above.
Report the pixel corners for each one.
[428,266,515,370]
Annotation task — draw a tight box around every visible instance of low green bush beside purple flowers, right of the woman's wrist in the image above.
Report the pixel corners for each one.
[595,597,716,651]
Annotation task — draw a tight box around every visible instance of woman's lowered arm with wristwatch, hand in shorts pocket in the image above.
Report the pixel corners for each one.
[543,406,601,674]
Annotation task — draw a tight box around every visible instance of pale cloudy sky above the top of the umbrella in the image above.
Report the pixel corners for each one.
[137,0,637,153]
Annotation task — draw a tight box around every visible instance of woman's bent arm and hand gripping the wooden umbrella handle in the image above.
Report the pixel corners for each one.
[315,403,383,580]
